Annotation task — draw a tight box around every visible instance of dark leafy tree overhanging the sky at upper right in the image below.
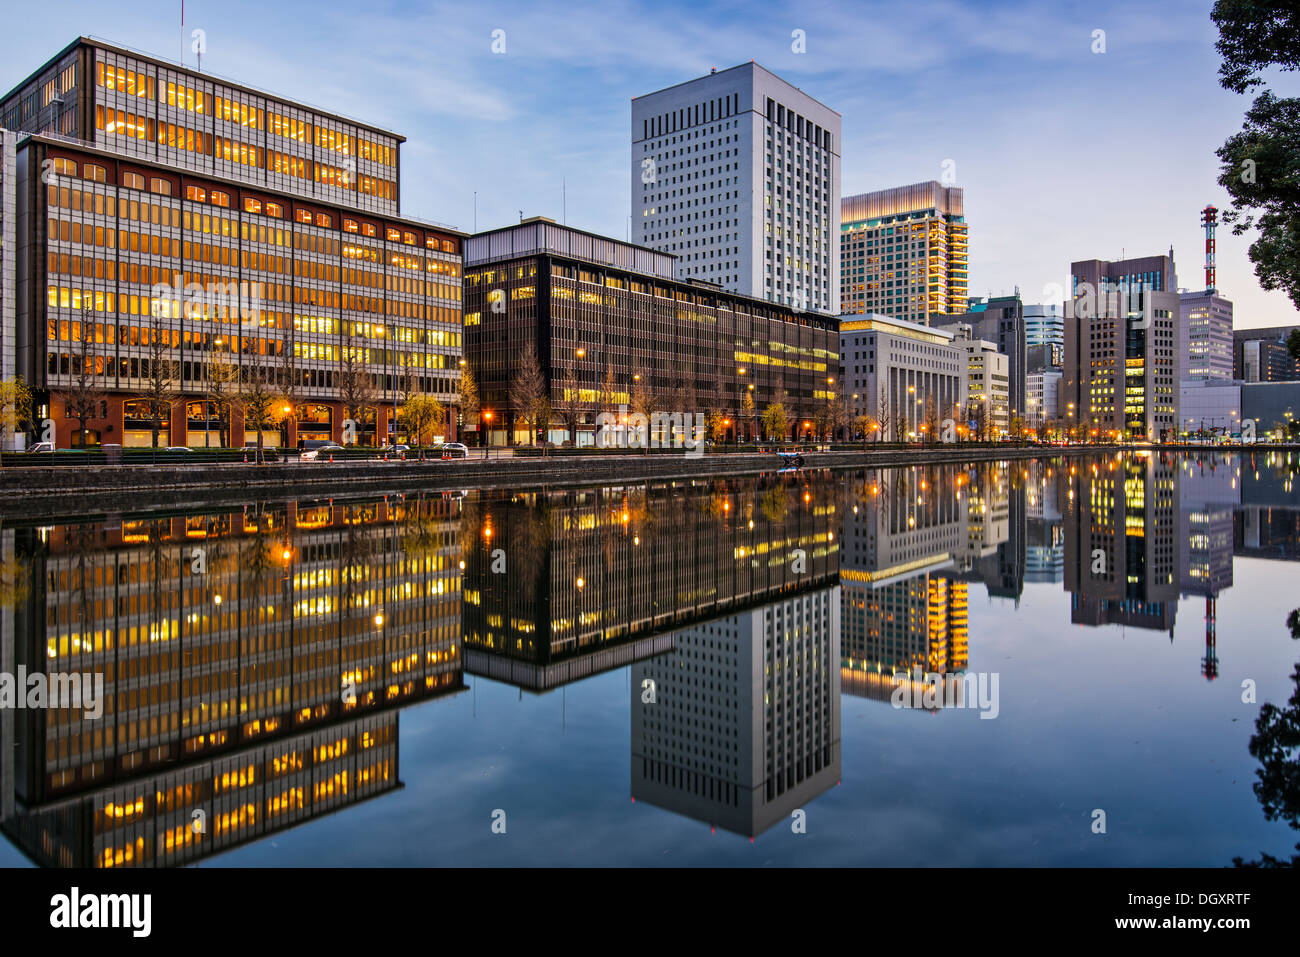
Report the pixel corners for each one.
[1210,0,1300,308]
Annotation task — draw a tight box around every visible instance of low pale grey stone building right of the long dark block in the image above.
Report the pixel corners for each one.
[840,315,967,442]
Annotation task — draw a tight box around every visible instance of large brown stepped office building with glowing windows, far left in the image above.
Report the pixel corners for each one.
[0,38,464,447]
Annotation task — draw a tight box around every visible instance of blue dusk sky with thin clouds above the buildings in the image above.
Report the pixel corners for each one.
[0,0,1300,328]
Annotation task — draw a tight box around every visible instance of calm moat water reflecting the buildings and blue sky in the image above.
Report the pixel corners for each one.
[0,455,1300,866]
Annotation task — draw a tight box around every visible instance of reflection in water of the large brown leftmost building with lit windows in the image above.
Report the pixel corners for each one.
[0,497,464,867]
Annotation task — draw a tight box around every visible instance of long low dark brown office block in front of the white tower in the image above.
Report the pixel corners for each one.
[465,217,839,445]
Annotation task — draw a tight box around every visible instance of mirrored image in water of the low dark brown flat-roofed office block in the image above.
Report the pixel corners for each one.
[463,473,840,690]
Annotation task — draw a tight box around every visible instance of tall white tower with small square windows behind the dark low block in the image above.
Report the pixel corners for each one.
[631,61,840,316]
